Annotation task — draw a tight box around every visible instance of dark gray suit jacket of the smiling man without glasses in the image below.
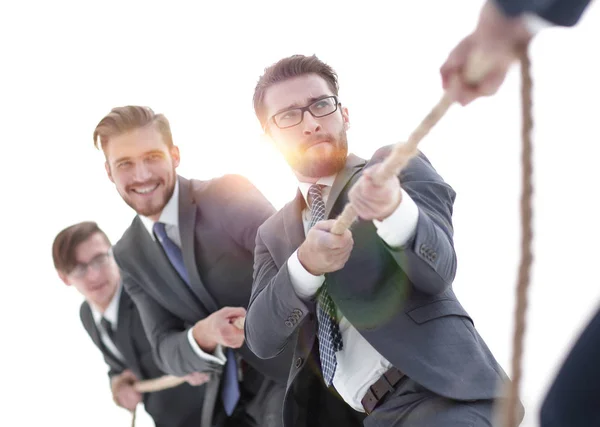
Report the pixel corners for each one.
[114,175,292,424]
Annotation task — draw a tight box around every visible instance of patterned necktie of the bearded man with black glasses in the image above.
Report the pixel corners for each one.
[308,184,343,386]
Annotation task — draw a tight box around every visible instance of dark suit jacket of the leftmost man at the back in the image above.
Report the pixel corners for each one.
[79,290,205,427]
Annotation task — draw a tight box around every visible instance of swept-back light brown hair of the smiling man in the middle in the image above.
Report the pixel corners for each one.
[94,105,173,150]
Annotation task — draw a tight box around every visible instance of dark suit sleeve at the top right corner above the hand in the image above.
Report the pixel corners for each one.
[494,0,590,27]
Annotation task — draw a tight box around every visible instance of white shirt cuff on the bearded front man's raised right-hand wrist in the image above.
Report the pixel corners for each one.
[373,188,419,248]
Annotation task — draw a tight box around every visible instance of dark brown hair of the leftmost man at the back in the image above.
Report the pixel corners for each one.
[52,221,110,273]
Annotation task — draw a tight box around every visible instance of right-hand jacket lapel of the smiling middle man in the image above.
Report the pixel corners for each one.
[179,177,219,313]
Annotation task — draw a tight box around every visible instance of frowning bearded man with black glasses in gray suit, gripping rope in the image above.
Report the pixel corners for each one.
[246,55,524,427]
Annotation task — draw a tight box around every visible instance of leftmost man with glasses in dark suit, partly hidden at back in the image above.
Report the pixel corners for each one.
[52,222,209,427]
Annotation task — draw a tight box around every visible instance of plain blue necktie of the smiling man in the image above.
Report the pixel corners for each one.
[153,222,240,415]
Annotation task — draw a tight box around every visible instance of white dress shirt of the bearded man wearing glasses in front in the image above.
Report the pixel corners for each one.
[287,175,419,412]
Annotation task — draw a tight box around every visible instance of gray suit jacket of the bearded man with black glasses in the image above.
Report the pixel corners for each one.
[246,147,506,423]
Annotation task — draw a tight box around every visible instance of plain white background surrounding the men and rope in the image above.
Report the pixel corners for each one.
[0,0,600,427]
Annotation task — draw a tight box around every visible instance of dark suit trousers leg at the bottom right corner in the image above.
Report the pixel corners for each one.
[540,309,600,427]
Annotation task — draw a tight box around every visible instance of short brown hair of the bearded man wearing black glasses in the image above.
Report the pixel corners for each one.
[253,55,339,127]
